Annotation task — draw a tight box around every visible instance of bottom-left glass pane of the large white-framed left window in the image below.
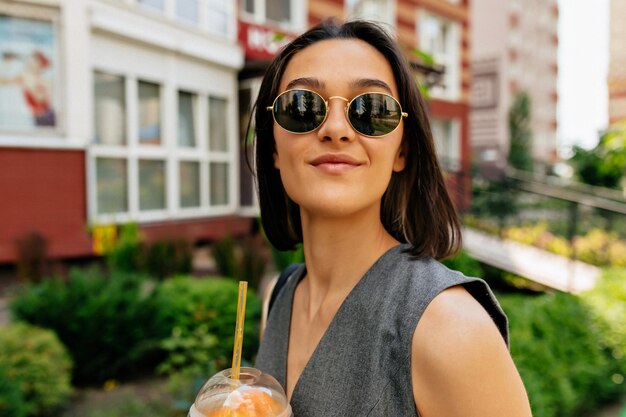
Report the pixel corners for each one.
[96,158,128,214]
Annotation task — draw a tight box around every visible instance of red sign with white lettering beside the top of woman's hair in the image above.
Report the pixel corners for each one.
[239,21,296,60]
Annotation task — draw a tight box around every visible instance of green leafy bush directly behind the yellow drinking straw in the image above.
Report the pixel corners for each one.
[157,277,261,370]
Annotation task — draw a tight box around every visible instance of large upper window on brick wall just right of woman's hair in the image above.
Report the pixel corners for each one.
[418,11,461,100]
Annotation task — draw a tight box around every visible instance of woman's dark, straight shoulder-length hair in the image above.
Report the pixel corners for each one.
[254,20,461,259]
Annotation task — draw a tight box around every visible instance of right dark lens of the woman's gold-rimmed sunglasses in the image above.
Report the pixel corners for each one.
[348,93,402,136]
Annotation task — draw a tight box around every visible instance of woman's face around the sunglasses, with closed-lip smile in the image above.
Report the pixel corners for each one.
[274,39,405,217]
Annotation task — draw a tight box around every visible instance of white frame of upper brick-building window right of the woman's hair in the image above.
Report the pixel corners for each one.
[417,9,461,101]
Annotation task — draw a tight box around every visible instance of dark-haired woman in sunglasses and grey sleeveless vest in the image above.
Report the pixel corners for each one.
[255,21,531,417]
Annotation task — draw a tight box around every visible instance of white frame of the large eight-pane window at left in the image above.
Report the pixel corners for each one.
[86,66,239,224]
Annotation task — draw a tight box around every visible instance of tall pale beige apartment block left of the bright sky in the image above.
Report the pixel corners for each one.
[470,0,559,170]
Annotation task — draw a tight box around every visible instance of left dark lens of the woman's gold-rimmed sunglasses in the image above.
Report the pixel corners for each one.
[274,90,326,133]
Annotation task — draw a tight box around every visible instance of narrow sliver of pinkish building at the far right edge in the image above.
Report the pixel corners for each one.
[608,0,626,125]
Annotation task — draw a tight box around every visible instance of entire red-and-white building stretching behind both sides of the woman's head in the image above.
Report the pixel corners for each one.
[0,0,470,263]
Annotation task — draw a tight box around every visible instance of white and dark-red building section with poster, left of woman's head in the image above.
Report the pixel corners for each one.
[0,0,251,262]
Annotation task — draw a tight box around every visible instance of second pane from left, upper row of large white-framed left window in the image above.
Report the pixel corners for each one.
[138,81,161,145]
